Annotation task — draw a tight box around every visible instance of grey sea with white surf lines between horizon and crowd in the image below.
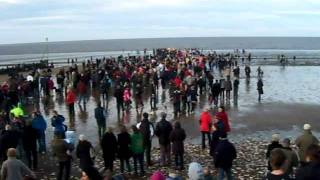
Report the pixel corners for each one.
[0,37,320,65]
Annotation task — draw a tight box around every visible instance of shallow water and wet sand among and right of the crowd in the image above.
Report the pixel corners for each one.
[23,66,320,148]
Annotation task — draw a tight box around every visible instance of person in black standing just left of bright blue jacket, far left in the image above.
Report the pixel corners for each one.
[22,124,38,169]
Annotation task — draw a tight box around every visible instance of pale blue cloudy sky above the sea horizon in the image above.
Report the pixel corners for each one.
[0,0,320,44]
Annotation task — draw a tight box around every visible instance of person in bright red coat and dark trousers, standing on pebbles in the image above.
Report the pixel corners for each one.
[200,108,212,149]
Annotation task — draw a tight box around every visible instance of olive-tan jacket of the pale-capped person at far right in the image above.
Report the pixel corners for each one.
[296,131,319,162]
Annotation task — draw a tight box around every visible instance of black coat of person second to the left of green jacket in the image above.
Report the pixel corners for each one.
[101,132,118,160]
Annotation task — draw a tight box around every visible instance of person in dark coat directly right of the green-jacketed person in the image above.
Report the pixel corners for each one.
[138,113,154,166]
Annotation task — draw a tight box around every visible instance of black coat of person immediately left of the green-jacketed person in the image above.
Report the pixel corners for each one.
[118,132,132,159]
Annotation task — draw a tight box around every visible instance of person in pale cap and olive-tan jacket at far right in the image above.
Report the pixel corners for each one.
[295,124,319,166]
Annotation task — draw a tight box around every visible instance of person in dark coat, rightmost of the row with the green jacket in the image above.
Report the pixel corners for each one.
[169,121,186,170]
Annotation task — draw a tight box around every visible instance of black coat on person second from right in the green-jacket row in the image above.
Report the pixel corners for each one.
[155,119,172,145]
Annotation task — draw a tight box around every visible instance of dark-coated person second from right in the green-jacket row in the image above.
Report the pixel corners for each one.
[155,112,172,166]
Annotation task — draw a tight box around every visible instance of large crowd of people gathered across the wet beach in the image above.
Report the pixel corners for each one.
[0,49,319,180]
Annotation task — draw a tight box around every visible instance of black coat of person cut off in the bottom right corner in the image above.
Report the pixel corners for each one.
[296,162,320,180]
